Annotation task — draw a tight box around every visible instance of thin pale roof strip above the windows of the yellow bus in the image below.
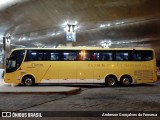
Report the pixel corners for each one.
[12,47,154,51]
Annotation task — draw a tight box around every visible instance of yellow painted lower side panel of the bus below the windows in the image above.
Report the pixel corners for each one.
[5,48,157,83]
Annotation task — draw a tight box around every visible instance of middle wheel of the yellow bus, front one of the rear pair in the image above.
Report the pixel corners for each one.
[105,75,117,87]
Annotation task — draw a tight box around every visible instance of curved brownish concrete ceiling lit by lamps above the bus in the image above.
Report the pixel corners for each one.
[0,0,160,59]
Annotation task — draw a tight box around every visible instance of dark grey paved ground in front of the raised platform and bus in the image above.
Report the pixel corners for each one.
[0,78,160,120]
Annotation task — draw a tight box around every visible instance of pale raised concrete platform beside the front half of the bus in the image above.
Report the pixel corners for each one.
[0,79,81,94]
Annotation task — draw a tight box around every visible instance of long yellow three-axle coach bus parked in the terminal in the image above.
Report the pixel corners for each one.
[4,47,157,87]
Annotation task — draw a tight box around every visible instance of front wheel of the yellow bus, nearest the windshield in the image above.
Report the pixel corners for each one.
[22,75,35,86]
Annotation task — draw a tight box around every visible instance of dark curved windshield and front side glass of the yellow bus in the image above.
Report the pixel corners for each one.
[6,50,24,73]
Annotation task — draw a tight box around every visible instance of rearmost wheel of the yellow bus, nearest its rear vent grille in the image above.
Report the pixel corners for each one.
[120,75,132,87]
